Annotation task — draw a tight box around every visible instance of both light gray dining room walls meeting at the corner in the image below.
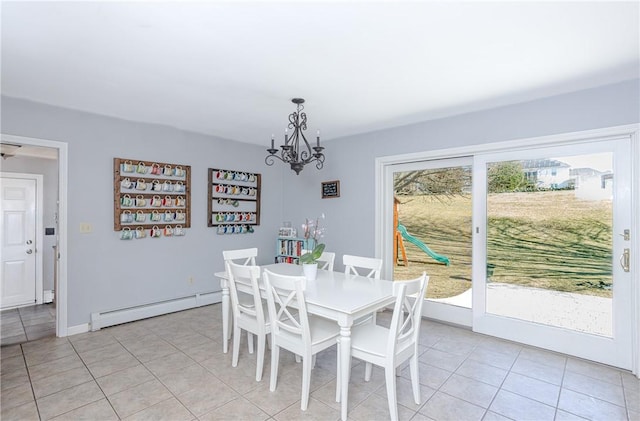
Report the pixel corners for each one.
[2,80,640,326]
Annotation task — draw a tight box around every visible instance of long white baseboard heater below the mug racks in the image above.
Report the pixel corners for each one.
[91,291,222,331]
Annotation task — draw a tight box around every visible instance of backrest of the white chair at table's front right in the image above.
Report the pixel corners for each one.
[387,272,429,355]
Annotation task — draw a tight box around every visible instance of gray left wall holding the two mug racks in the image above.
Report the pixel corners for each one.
[2,97,283,326]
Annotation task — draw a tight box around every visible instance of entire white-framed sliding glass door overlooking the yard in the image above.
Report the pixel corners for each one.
[376,134,637,369]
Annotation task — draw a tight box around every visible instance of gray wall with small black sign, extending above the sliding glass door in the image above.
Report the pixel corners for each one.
[283,79,640,270]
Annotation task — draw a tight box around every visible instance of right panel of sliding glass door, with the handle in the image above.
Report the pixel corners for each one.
[473,137,634,369]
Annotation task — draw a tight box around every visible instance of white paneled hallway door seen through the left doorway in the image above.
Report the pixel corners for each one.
[0,177,37,308]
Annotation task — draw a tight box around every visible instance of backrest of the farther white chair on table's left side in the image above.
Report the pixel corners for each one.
[225,260,265,324]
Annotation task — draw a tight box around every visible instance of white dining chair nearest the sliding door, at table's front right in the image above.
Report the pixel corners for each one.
[336,272,429,420]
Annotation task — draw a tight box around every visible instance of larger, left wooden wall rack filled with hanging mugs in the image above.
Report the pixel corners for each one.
[113,158,191,231]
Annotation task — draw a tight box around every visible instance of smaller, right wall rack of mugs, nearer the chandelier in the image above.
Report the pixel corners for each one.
[207,168,261,234]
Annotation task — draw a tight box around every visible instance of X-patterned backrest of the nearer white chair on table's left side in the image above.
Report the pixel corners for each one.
[262,269,311,348]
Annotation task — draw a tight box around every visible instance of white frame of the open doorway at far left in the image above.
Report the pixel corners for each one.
[0,133,68,337]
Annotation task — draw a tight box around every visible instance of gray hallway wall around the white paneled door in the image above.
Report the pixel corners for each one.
[0,156,58,290]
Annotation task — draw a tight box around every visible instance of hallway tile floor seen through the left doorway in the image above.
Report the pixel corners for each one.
[0,303,56,346]
